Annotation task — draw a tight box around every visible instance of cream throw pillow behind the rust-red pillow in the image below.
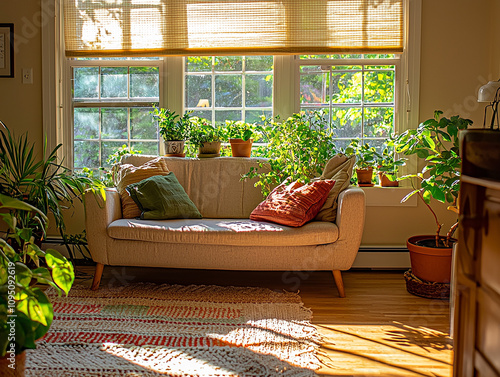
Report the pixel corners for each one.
[314,154,356,221]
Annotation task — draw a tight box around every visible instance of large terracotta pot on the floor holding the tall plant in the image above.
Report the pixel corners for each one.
[406,236,455,283]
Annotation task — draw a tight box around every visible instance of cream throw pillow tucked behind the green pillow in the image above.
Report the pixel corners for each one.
[113,157,170,219]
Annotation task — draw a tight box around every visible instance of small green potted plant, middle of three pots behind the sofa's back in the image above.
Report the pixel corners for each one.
[189,117,225,158]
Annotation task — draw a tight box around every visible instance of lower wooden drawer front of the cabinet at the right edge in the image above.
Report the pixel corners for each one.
[476,288,500,373]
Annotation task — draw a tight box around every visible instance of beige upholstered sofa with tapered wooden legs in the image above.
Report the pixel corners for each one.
[85,155,365,297]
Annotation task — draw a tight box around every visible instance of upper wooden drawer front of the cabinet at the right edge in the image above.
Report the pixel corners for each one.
[480,195,500,294]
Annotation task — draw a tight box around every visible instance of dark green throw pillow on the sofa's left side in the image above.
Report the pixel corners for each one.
[127,172,202,220]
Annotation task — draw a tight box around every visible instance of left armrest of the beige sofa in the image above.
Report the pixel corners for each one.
[84,188,122,264]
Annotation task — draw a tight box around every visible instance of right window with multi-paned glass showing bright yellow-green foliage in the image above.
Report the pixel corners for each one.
[299,54,398,148]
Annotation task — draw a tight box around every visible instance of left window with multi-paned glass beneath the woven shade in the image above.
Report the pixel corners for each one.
[72,62,160,169]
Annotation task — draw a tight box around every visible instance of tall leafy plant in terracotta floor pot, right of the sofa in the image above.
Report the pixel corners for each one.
[396,111,472,283]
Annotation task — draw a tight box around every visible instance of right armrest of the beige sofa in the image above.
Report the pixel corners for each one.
[335,186,366,268]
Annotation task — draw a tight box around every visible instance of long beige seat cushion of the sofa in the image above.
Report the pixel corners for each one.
[107,219,339,247]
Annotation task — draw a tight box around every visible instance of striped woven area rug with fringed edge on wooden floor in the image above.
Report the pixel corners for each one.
[26,284,319,377]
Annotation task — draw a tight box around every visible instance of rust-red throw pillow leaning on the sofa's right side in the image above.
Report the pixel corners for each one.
[250,179,335,227]
